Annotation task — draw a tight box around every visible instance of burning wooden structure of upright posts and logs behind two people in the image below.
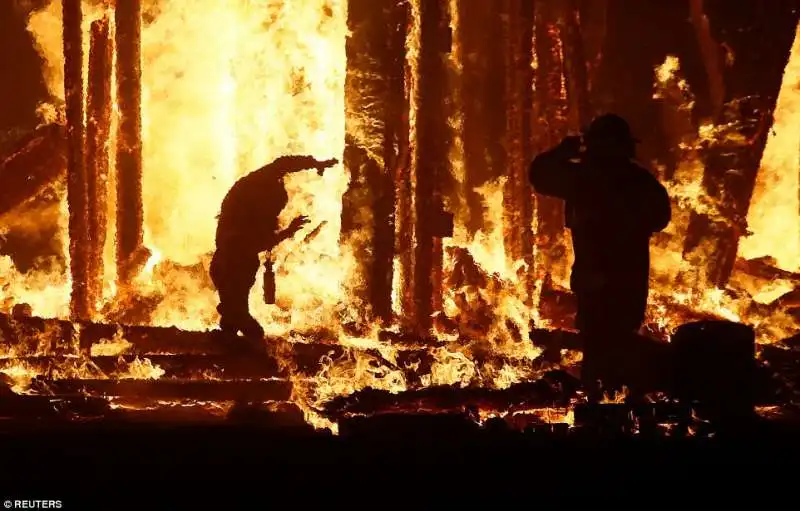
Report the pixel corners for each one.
[0,0,800,430]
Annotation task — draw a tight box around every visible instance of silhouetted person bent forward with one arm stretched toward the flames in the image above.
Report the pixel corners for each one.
[210,156,337,339]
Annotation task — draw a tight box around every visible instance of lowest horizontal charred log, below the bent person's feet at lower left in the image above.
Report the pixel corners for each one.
[40,380,292,402]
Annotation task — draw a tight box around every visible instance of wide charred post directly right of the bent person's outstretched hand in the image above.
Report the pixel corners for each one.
[342,0,407,322]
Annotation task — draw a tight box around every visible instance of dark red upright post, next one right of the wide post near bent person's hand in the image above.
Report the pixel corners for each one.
[412,2,452,336]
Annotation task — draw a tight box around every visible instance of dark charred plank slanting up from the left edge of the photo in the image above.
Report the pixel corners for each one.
[0,124,67,219]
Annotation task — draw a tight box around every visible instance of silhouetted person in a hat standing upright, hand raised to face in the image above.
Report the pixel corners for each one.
[530,114,671,390]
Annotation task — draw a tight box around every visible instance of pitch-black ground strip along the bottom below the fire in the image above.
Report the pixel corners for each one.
[0,418,800,510]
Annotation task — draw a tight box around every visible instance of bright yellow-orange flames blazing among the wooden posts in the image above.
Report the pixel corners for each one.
[0,0,800,429]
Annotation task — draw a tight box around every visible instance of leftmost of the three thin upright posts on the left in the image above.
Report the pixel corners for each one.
[62,0,90,319]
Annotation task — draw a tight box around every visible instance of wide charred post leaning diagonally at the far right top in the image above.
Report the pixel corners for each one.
[684,0,798,288]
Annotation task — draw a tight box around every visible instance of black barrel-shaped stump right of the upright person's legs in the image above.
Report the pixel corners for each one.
[672,321,756,422]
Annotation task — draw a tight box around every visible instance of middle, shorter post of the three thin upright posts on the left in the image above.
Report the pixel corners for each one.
[86,17,113,312]
